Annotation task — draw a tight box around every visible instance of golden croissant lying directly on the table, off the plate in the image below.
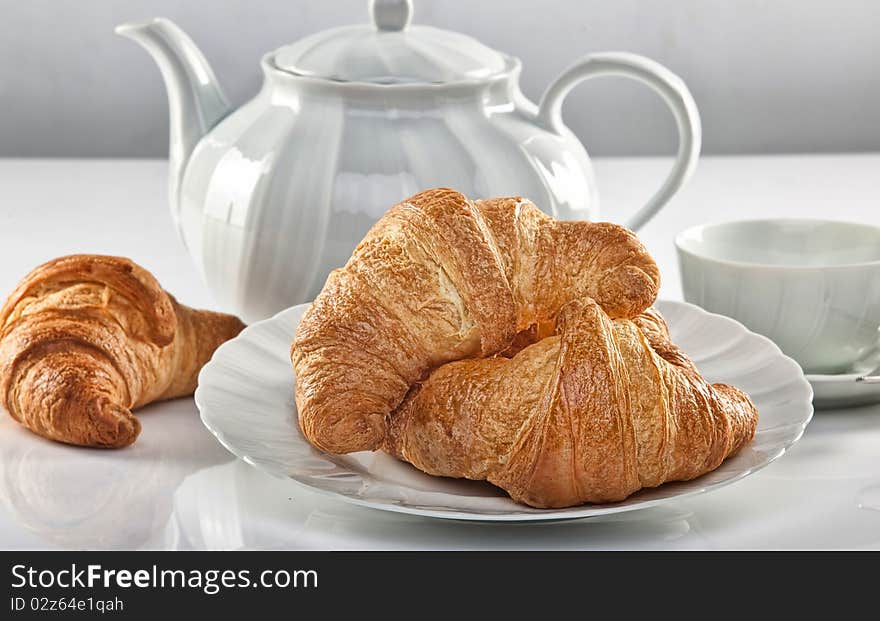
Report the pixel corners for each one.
[0,255,244,448]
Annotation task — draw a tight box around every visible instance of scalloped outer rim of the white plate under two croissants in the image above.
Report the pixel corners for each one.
[194,300,814,522]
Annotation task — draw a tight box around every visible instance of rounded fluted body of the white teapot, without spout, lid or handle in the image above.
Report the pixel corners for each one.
[182,59,598,322]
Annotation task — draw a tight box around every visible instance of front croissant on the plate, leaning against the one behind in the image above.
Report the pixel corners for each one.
[384,299,757,508]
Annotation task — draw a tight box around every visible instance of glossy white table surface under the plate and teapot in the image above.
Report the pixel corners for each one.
[0,155,880,549]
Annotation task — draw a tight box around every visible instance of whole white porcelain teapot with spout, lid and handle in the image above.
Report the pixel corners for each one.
[117,0,700,321]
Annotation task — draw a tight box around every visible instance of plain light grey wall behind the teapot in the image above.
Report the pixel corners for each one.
[0,0,880,157]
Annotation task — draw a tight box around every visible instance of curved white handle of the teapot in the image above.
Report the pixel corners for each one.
[537,52,702,230]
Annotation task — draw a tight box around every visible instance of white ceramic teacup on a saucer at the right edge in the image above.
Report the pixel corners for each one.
[675,219,880,373]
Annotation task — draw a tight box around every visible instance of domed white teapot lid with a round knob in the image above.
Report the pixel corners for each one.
[275,0,507,84]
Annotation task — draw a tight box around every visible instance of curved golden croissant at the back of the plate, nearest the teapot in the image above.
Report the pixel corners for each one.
[291,188,660,453]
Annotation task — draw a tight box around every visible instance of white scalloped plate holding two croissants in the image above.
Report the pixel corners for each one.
[195,302,813,521]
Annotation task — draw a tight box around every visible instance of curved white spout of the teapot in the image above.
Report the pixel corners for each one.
[116,17,230,217]
